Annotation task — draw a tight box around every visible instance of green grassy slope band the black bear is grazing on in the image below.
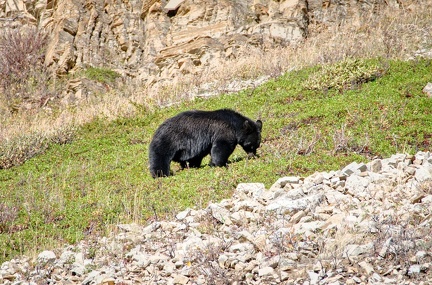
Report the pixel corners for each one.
[0,60,432,262]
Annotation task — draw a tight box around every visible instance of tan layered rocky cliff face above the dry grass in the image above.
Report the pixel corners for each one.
[0,0,408,87]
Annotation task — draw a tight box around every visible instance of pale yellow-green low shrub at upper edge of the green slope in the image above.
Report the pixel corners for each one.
[303,58,385,90]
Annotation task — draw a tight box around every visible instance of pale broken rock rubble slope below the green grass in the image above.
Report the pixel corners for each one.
[0,152,432,285]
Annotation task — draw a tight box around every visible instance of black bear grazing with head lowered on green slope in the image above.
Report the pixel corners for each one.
[149,109,262,178]
